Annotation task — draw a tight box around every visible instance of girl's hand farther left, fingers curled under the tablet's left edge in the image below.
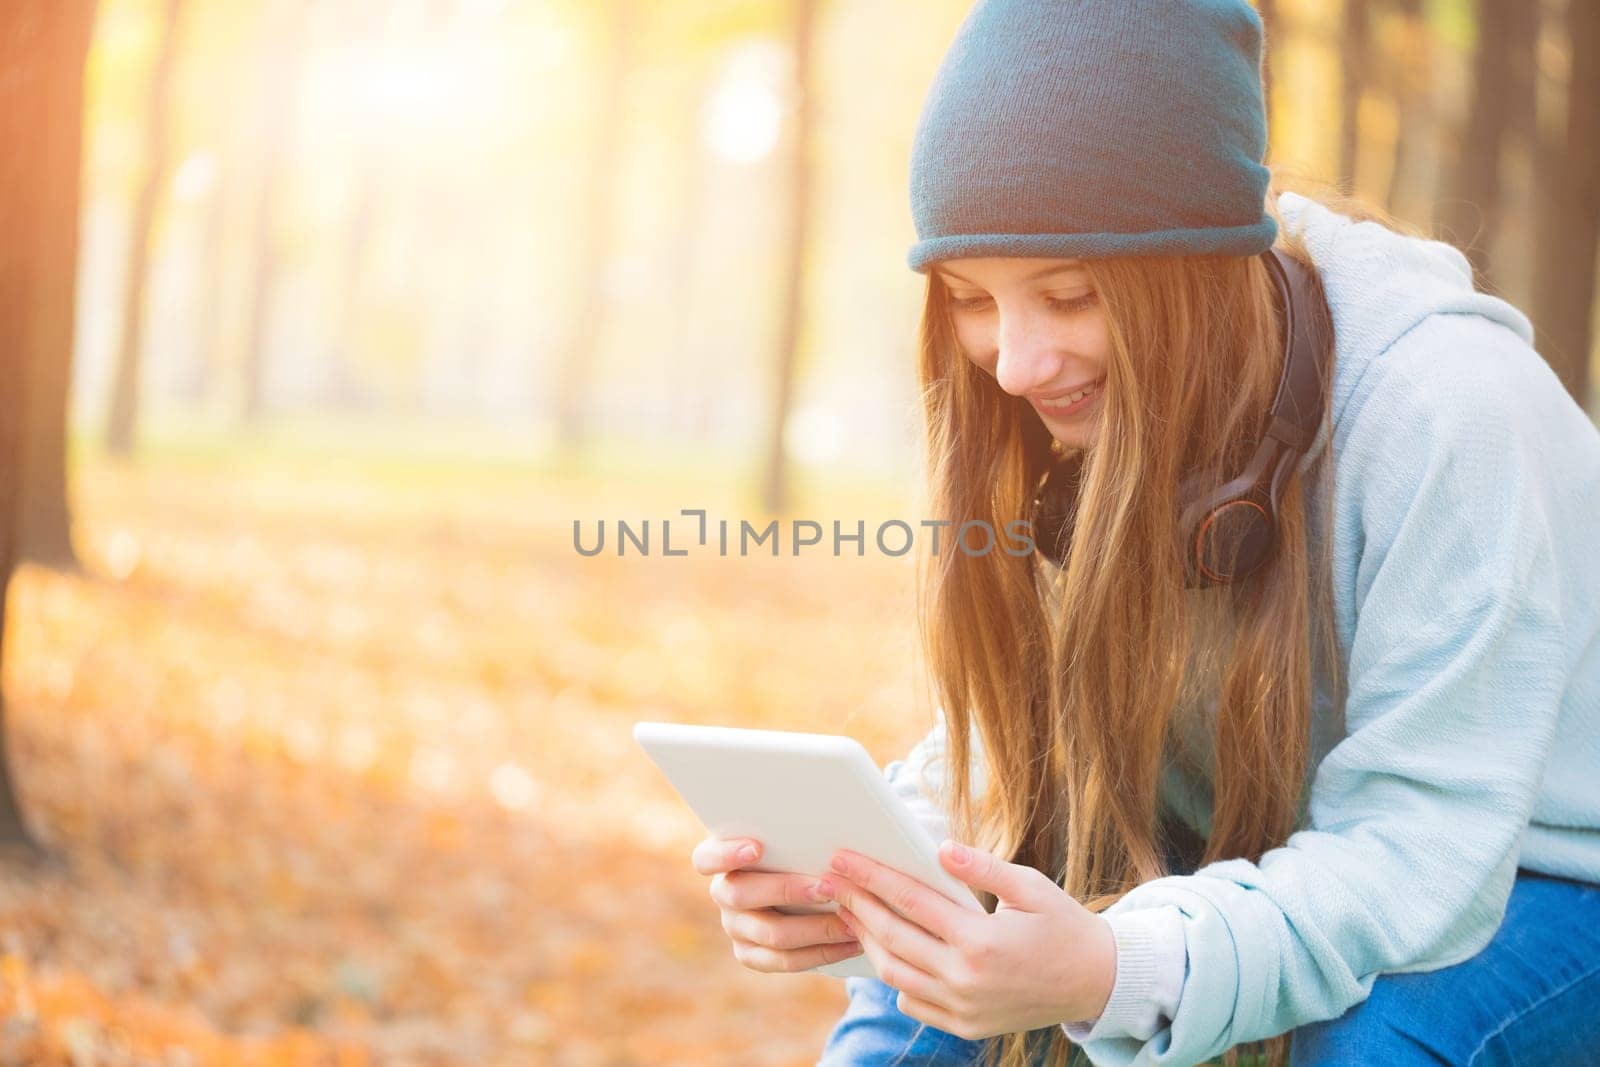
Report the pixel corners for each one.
[693,837,861,971]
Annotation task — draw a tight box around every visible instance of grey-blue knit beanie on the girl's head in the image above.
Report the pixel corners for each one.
[907,0,1277,272]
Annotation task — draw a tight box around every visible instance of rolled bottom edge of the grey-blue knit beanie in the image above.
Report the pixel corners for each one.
[906,216,1278,274]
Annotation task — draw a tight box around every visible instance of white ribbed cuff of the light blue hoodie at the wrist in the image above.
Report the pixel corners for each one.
[1061,904,1189,1045]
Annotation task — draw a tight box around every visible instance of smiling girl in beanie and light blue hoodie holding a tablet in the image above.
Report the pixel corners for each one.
[694,0,1600,1065]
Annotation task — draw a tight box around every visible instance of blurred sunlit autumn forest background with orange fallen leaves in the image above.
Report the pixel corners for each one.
[0,0,1600,1067]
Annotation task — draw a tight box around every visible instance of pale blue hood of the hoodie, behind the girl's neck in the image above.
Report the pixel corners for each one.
[1278,192,1533,470]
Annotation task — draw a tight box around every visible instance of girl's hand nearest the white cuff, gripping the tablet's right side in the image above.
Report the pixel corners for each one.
[822,841,1117,1040]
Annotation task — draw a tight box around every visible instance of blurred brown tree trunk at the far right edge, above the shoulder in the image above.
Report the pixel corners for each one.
[1533,0,1600,408]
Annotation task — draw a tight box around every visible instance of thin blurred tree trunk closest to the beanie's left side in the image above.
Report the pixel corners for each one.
[762,0,818,512]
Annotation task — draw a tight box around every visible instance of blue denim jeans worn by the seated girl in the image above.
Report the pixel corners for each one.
[818,831,1600,1067]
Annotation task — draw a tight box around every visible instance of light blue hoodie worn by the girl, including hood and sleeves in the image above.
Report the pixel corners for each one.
[885,194,1600,1067]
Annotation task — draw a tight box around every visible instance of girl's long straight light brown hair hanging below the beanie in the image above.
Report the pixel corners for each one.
[918,181,1427,1067]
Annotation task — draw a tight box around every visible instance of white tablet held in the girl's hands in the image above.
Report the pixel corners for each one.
[634,723,982,977]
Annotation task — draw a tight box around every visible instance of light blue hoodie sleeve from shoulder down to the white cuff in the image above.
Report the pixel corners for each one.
[1083,315,1566,1067]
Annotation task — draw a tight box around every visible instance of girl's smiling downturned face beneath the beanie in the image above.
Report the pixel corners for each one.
[934,256,1110,448]
